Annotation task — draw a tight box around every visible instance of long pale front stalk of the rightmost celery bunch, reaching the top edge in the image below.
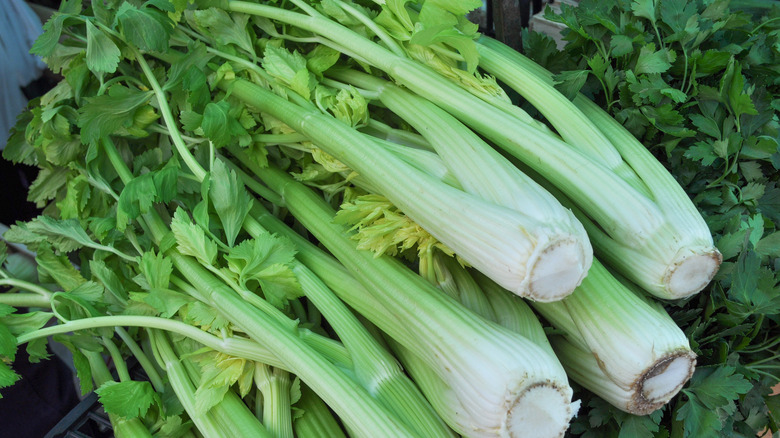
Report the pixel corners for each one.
[229,1,717,302]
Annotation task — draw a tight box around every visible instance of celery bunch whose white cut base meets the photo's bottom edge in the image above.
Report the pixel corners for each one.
[247,164,572,436]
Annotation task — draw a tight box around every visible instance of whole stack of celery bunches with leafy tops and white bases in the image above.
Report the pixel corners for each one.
[0,0,720,437]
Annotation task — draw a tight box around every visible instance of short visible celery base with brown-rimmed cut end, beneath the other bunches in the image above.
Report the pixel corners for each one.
[532,261,696,415]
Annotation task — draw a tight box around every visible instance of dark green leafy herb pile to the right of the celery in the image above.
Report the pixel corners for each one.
[523,0,780,436]
